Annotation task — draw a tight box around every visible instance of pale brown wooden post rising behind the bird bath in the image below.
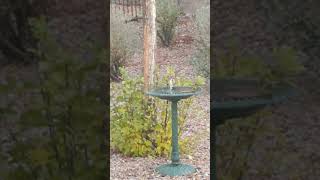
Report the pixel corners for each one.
[143,0,157,92]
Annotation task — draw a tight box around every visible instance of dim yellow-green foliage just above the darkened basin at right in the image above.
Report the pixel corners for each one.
[212,41,305,89]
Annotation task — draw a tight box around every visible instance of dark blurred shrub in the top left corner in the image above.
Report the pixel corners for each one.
[0,0,47,64]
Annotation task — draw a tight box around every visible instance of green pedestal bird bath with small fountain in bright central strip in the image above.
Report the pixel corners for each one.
[146,84,200,176]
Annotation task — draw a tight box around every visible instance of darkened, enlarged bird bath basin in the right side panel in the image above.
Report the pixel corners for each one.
[211,79,295,126]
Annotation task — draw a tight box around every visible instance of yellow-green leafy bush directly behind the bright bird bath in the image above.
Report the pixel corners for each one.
[110,67,202,156]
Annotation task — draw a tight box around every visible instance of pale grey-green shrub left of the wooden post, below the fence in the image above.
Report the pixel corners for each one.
[110,11,142,81]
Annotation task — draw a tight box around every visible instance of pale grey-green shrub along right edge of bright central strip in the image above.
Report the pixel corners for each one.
[191,6,210,78]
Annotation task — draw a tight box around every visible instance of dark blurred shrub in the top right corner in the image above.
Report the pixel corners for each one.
[257,0,320,75]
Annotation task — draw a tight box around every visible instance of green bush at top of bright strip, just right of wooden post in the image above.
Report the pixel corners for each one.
[156,0,180,47]
